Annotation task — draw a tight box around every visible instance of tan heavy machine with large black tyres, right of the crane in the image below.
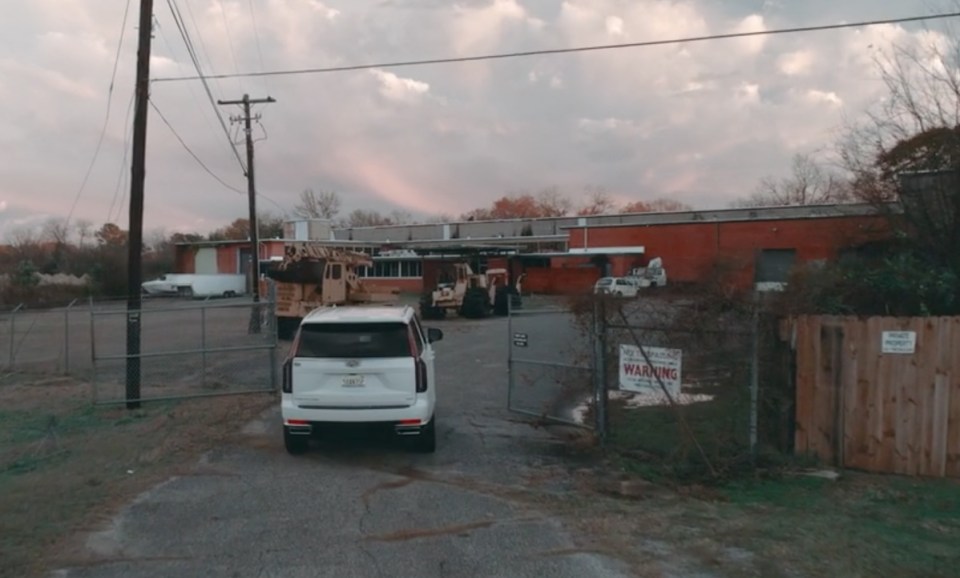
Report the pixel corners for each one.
[420,262,522,319]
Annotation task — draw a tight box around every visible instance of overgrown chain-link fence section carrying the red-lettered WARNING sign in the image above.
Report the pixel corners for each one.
[548,295,793,478]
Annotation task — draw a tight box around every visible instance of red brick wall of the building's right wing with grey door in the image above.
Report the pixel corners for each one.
[570,217,888,286]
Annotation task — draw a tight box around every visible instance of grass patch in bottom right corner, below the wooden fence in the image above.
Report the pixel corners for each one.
[720,475,960,577]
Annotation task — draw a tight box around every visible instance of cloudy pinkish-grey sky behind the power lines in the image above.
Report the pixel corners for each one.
[0,0,956,237]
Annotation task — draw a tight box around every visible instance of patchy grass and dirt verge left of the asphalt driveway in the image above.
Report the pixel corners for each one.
[0,384,273,578]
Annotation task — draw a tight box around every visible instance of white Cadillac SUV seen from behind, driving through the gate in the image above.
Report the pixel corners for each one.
[280,306,443,454]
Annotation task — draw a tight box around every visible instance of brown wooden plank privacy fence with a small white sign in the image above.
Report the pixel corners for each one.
[790,316,960,477]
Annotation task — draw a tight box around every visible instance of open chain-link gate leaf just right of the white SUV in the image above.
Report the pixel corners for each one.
[507,307,604,429]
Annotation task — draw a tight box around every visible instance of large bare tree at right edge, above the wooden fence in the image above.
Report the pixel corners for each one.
[839,15,960,273]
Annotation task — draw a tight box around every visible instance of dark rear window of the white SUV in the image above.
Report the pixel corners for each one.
[295,323,410,359]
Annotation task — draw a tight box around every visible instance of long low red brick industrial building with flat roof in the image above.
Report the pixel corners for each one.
[175,204,888,293]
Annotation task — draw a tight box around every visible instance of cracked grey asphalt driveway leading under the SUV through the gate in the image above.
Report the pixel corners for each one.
[54,319,631,578]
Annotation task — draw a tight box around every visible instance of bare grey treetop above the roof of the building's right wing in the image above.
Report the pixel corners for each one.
[733,154,853,207]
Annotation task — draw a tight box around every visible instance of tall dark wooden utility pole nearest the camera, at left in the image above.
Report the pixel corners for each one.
[126,0,153,409]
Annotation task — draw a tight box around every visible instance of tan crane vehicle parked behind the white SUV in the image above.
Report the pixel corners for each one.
[265,242,399,339]
